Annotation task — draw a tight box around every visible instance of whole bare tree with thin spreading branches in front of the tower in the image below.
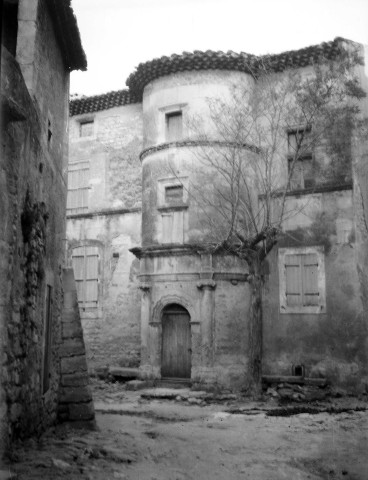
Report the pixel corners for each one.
[181,48,364,393]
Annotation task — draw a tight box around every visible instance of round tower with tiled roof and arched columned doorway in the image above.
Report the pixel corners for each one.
[127,52,254,388]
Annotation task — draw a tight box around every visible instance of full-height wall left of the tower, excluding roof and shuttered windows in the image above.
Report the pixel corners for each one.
[67,104,142,371]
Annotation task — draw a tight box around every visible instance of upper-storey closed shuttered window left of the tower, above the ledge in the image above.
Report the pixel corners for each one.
[66,162,89,214]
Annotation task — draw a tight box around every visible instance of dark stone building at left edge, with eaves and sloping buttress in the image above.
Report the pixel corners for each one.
[0,0,93,454]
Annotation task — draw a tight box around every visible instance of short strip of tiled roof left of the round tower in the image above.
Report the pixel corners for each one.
[69,89,140,117]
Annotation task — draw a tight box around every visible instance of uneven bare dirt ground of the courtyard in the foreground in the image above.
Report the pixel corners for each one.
[0,381,368,480]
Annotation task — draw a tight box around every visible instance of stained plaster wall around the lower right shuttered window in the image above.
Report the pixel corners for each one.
[263,190,367,386]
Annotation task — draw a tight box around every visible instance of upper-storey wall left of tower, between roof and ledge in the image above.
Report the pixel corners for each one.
[69,104,143,212]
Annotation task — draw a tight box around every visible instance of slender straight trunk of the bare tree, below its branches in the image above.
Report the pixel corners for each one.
[247,259,263,396]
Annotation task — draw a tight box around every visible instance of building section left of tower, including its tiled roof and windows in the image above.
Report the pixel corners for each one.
[67,90,143,370]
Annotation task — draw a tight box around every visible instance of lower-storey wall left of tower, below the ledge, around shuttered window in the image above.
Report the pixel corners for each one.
[67,210,141,371]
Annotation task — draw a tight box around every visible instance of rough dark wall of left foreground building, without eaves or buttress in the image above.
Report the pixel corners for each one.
[0,1,69,450]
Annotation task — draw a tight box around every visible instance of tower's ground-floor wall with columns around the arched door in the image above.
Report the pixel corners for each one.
[140,248,249,389]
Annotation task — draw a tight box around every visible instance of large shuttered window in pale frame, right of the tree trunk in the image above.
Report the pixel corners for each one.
[279,247,326,313]
